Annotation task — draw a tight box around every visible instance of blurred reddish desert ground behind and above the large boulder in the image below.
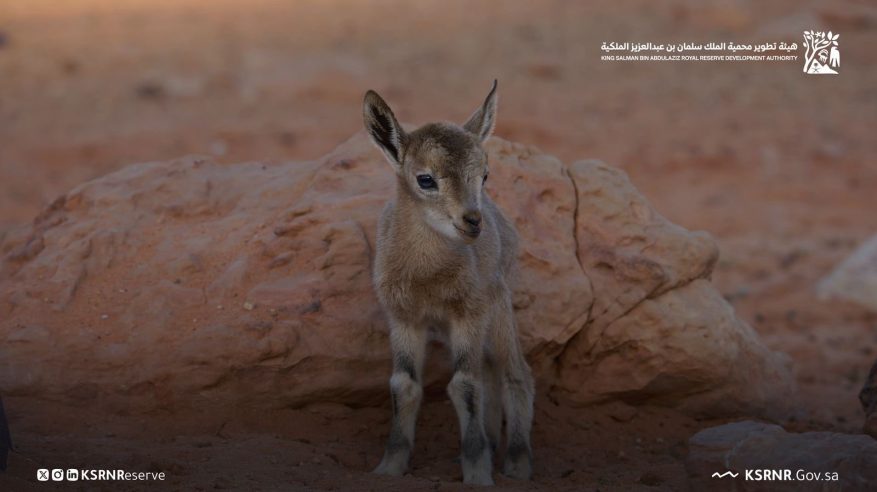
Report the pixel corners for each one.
[0,0,877,430]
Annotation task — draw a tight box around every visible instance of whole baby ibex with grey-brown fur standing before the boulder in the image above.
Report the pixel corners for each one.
[363,81,533,485]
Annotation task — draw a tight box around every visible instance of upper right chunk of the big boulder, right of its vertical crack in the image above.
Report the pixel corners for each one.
[569,161,718,331]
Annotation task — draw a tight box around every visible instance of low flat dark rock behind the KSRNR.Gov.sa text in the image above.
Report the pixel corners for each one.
[685,421,877,491]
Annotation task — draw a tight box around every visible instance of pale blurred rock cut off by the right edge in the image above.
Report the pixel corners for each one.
[817,235,877,311]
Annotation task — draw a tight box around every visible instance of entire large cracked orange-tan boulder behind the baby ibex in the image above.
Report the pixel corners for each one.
[0,135,791,415]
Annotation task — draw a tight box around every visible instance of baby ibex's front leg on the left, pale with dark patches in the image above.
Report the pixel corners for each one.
[374,322,426,476]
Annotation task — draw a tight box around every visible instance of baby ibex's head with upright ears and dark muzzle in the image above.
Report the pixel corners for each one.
[363,81,496,242]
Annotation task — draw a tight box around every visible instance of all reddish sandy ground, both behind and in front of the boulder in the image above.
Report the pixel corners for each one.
[0,0,877,490]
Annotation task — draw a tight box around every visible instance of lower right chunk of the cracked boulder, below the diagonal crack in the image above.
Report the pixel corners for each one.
[557,279,789,417]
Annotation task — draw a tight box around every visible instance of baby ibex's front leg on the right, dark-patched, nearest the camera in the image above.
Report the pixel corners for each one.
[448,319,493,485]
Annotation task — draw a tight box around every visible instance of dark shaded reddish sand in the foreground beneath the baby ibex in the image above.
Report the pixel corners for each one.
[0,398,711,490]
